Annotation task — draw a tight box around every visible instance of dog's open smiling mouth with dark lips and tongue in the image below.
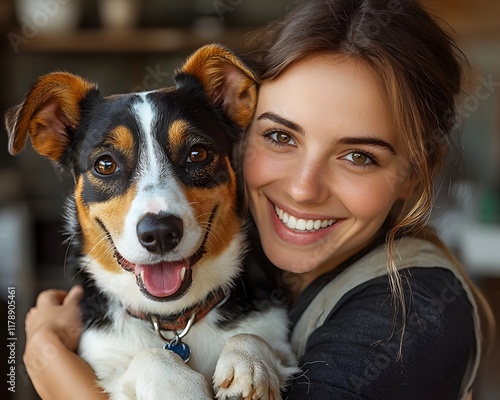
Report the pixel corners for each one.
[98,207,217,301]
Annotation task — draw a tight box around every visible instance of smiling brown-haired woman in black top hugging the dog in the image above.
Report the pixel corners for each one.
[25,0,491,399]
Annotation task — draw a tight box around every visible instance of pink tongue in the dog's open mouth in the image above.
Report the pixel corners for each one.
[135,260,189,297]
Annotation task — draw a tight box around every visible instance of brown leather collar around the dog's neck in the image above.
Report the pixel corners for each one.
[127,289,228,332]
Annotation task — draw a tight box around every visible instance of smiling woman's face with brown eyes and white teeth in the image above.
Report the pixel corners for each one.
[243,54,412,291]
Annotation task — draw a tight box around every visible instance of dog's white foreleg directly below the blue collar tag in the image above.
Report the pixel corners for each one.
[115,348,214,400]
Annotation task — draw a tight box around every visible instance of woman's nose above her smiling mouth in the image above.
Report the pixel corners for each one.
[285,159,331,204]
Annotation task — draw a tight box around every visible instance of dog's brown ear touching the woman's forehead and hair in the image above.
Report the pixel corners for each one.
[174,44,257,127]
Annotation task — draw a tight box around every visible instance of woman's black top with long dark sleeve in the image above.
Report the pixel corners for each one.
[283,260,475,400]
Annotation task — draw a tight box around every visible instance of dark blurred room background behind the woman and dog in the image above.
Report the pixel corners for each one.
[0,0,500,400]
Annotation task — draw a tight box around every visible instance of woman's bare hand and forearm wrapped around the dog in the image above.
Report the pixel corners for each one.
[23,286,108,400]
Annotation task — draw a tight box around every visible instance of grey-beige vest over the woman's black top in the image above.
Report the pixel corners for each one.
[291,238,481,399]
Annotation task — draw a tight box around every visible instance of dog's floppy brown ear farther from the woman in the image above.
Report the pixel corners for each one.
[5,72,97,162]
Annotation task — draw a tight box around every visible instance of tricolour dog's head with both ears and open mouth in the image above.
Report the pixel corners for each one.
[6,45,256,312]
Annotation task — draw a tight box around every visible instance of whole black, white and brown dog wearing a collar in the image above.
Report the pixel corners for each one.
[6,44,297,400]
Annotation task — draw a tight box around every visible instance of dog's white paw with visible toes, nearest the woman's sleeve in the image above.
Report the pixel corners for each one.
[214,334,289,400]
